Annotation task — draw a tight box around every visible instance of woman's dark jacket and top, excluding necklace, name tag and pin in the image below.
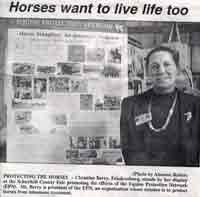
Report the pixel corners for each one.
[120,90,200,166]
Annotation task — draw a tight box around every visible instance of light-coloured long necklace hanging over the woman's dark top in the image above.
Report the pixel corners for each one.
[148,93,177,133]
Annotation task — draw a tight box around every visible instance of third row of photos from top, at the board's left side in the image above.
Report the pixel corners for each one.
[12,76,88,100]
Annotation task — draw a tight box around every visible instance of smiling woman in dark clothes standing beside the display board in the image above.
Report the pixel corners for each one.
[120,46,200,166]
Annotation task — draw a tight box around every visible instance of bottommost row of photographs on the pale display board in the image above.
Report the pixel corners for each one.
[66,149,124,165]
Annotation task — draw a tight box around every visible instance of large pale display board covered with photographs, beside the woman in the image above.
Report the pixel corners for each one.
[6,22,128,163]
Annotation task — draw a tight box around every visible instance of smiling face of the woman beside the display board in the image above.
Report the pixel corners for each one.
[149,51,177,90]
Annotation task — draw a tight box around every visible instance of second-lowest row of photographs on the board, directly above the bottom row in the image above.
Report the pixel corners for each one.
[70,136,120,149]
